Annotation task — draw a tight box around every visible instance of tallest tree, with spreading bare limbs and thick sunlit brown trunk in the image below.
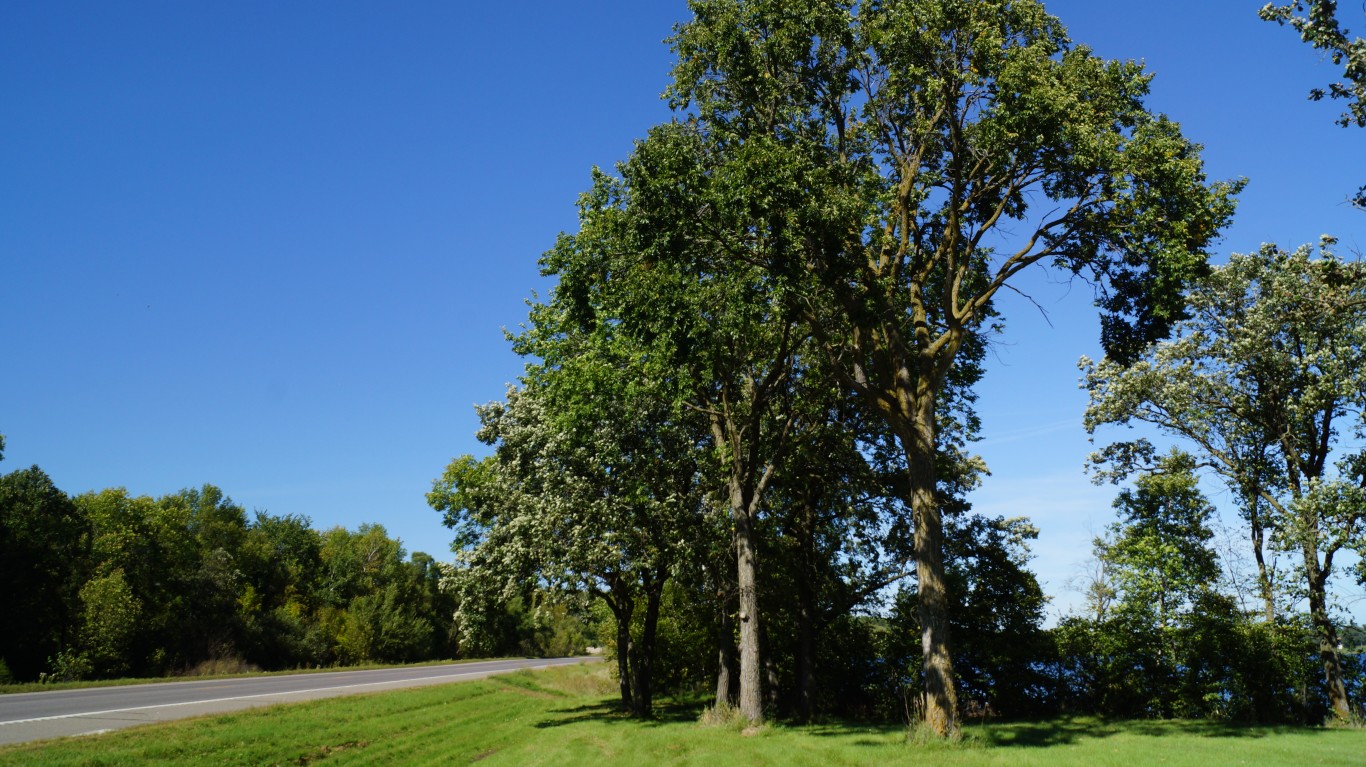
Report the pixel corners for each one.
[657,0,1239,734]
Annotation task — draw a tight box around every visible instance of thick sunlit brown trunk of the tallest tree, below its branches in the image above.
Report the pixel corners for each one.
[899,381,958,737]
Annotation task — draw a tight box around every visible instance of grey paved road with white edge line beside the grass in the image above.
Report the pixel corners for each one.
[0,658,596,744]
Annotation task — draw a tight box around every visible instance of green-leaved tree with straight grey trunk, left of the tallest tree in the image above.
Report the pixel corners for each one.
[542,144,806,722]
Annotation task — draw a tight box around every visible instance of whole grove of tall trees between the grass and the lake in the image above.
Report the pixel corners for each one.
[429,0,1366,736]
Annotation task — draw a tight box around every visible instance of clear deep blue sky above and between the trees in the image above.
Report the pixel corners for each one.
[0,0,1366,611]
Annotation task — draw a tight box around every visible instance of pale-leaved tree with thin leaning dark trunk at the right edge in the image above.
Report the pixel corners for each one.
[1082,238,1366,718]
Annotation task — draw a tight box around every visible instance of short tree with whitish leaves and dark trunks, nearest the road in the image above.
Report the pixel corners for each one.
[428,329,710,716]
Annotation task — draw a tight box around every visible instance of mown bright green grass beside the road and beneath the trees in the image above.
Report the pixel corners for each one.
[0,664,1366,767]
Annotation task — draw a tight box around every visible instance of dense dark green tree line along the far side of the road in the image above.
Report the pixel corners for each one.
[0,448,589,682]
